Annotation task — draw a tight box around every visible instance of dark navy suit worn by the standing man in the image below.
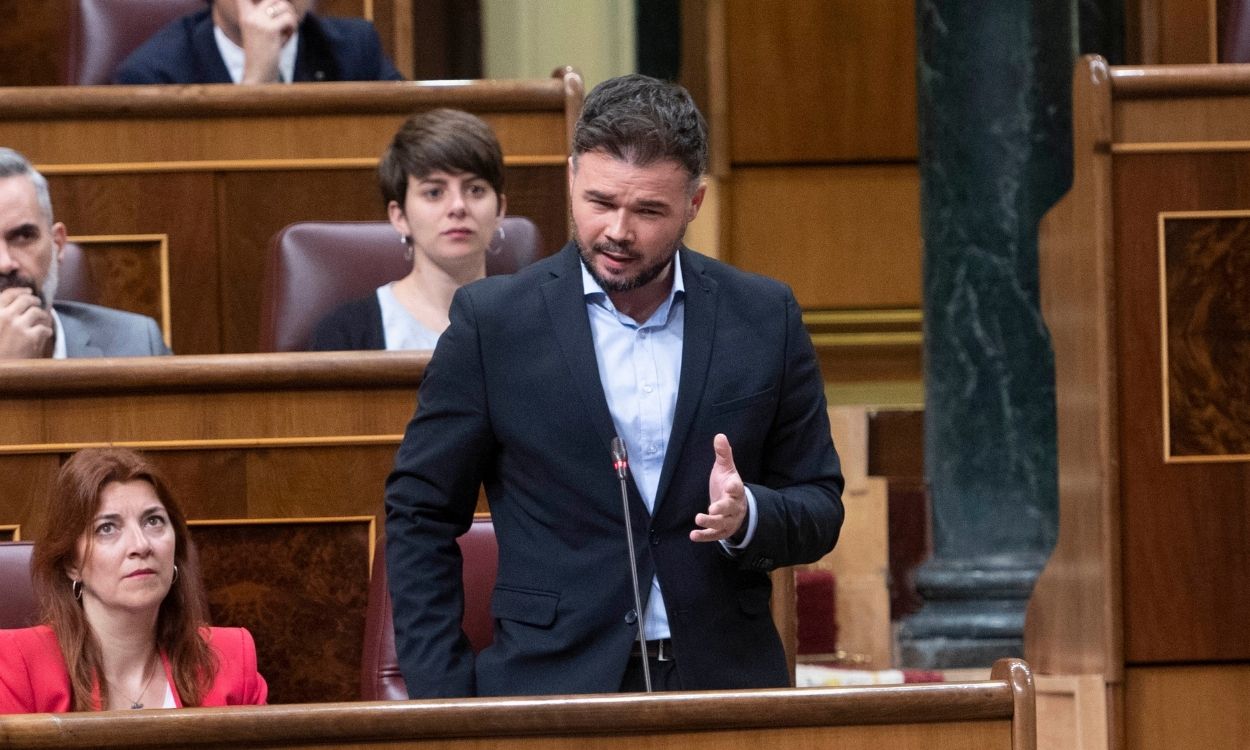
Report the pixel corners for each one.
[386,244,843,696]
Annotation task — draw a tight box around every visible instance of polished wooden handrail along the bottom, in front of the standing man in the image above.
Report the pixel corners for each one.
[0,660,1035,750]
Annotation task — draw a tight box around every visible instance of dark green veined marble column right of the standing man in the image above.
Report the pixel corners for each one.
[900,0,1076,668]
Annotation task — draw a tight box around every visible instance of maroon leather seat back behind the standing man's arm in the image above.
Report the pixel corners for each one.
[360,519,499,700]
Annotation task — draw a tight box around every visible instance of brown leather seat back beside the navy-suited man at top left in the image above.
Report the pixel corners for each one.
[61,0,204,86]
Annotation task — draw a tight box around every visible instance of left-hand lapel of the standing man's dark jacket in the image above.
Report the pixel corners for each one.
[543,243,616,447]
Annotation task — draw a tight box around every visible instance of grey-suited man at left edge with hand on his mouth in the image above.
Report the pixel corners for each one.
[0,149,170,359]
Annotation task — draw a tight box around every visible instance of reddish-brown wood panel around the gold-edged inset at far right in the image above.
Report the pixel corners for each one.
[1114,154,1250,664]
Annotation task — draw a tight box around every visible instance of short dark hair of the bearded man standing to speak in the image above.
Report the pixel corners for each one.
[573,74,708,180]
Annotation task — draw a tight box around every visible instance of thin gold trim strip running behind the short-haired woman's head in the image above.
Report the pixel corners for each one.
[36,154,569,175]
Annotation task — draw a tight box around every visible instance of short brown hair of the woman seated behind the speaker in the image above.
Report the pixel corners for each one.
[378,109,504,208]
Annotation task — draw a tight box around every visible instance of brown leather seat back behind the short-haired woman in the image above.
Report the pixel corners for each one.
[260,216,541,351]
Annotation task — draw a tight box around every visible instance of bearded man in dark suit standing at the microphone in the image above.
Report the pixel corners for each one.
[386,75,843,696]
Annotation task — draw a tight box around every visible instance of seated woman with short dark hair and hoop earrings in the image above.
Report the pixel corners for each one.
[310,109,508,351]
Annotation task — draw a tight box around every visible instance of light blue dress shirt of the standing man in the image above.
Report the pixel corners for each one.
[581,259,756,640]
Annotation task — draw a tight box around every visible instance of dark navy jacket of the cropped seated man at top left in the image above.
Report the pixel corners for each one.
[113,9,403,84]
